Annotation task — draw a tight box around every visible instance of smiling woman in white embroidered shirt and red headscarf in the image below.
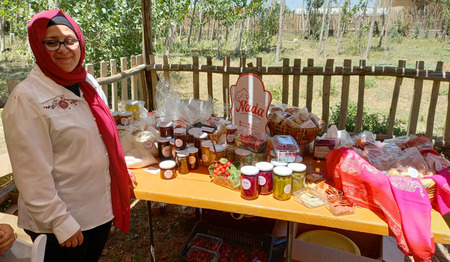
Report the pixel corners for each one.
[2,10,135,261]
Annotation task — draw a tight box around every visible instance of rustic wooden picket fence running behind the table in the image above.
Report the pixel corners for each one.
[4,56,450,149]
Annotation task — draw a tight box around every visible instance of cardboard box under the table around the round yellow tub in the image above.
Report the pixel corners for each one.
[273,221,405,262]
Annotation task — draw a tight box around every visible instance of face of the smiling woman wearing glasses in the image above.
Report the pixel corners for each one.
[42,25,81,73]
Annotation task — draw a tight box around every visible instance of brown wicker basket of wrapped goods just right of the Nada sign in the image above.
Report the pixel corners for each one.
[269,120,325,145]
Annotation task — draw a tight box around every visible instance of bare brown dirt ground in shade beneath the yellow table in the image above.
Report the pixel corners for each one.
[100,201,450,262]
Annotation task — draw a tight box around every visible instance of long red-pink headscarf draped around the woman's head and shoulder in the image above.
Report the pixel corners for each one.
[28,9,130,232]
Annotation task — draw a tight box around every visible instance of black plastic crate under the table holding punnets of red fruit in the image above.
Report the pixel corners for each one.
[180,221,274,262]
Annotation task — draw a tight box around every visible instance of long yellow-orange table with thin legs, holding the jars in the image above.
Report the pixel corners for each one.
[134,157,450,261]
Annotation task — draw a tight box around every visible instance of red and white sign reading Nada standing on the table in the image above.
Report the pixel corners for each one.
[230,74,272,133]
